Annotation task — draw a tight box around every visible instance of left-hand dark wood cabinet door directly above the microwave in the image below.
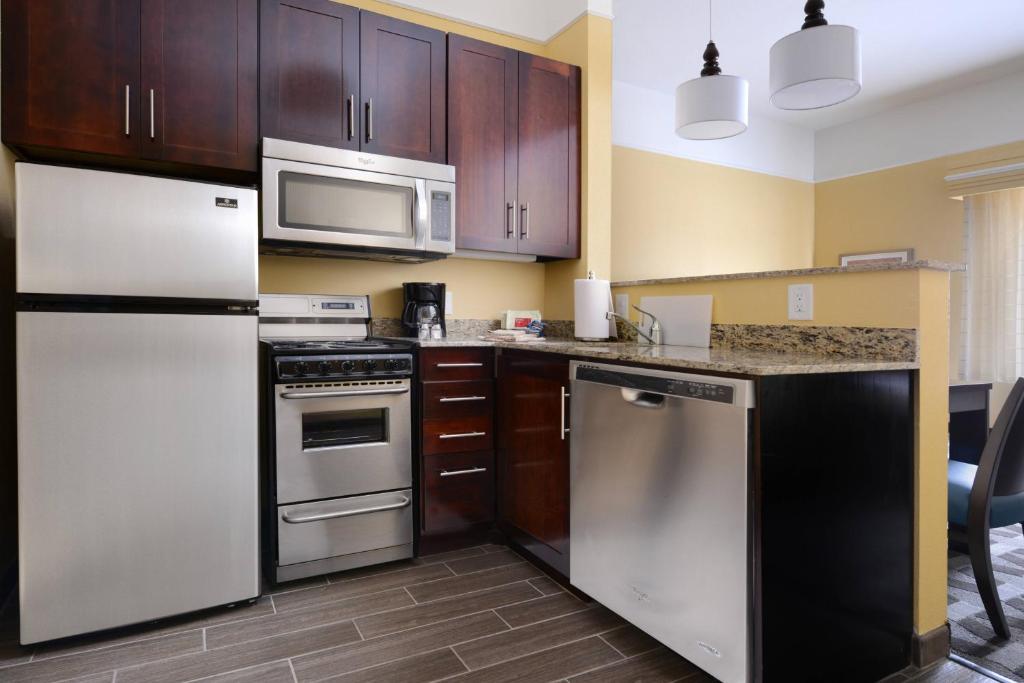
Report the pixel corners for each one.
[260,0,362,150]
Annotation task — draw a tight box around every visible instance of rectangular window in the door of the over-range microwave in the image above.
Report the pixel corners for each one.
[278,171,416,238]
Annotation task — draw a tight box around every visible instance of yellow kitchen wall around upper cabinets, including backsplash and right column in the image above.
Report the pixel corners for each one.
[260,0,611,319]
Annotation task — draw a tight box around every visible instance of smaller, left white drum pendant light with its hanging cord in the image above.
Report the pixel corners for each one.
[676,0,750,140]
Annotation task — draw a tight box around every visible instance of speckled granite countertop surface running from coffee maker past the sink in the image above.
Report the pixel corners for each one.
[385,337,919,375]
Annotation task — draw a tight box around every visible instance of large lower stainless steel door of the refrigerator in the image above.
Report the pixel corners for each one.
[17,312,259,643]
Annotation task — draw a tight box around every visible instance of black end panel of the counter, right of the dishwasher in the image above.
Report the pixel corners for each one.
[755,372,913,682]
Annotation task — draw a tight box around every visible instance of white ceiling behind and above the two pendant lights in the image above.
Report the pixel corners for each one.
[613,0,1024,130]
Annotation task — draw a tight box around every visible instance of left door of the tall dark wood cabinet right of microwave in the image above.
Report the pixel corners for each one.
[447,34,519,253]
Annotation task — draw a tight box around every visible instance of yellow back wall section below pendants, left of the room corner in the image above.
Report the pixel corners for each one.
[611,146,814,280]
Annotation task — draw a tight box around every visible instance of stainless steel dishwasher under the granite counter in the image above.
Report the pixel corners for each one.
[569,361,754,683]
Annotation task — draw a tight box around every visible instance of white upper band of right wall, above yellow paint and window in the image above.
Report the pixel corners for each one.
[814,72,1024,181]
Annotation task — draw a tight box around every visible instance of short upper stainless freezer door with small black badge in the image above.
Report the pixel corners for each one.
[15,163,258,300]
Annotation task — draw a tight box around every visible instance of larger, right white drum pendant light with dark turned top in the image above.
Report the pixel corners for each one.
[768,0,860,110]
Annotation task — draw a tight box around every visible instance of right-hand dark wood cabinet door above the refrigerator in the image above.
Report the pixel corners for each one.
[142,0,259,171]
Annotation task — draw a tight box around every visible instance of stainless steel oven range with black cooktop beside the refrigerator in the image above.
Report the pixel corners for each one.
[260,295,414,582]
